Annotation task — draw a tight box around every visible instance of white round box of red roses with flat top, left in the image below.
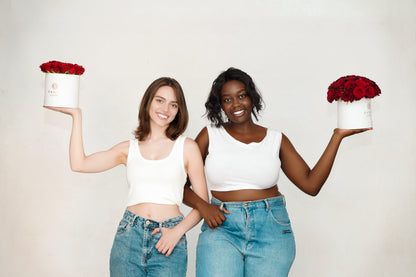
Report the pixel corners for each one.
[40,61,85,108]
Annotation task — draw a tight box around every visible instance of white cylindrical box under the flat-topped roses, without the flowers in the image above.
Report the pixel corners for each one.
[44,73,80,108]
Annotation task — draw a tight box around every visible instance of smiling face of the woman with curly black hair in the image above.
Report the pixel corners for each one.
[221,80,253,123]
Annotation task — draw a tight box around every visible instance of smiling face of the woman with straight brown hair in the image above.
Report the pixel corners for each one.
[149,86,178,128]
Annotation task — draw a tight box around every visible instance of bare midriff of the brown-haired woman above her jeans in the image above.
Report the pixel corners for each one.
[127,203,181,222]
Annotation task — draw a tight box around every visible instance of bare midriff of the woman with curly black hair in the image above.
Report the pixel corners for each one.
[211,185,282,202]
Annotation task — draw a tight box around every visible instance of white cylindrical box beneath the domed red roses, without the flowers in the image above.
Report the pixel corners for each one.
[337,98,373,129]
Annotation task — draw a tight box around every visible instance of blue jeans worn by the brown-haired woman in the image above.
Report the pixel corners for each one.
[110,210,188,277]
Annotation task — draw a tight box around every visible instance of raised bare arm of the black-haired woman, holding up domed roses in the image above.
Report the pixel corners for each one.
[280,129,369,196]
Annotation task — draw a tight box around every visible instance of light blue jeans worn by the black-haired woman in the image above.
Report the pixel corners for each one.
[196,196,296,277]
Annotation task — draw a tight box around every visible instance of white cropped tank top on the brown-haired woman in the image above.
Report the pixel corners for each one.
[127,136,187,206]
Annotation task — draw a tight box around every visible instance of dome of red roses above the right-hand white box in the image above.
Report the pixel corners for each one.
[327,75,381,103]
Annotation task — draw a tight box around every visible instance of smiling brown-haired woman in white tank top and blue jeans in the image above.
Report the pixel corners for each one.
[46,77,208,277]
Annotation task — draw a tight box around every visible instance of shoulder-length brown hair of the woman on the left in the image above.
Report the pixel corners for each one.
[134,77,189,141]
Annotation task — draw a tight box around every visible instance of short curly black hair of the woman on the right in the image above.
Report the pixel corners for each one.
[205,67,263,127]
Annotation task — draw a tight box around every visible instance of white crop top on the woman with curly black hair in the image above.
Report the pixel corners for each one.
[205,126,282,191]
